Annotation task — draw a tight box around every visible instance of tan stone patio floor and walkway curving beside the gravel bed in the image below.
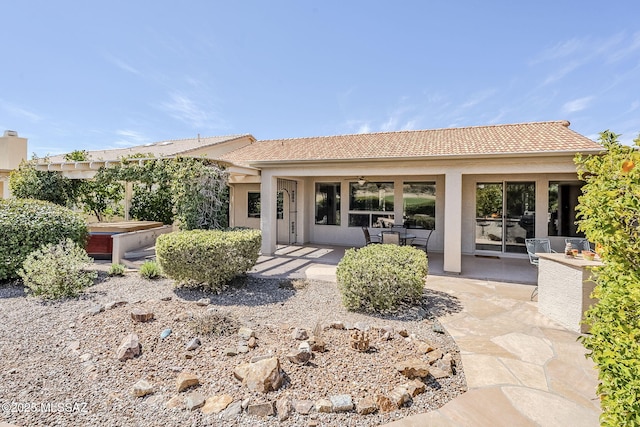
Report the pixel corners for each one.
[253,246,600,427]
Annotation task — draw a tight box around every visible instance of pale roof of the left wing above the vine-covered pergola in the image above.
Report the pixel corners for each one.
[48,134,254,163]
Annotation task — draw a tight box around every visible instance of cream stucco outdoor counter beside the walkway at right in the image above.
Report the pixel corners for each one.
[537,253,602,332]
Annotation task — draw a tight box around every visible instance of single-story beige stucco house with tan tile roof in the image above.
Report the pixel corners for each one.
[30,121,602,273]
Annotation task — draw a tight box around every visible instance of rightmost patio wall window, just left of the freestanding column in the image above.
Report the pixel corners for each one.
[402,182,436,230]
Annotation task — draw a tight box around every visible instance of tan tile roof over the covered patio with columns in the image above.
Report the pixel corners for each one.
[221,121,602,165]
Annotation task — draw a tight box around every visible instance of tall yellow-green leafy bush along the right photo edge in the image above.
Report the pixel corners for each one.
[576,131,640,426]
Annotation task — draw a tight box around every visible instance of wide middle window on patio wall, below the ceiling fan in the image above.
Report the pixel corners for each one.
[349,182,394,228]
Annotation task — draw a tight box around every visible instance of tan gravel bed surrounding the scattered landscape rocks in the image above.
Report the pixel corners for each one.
[0,266,466,426]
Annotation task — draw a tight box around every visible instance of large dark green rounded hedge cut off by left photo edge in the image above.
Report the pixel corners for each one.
[0,199,87,280]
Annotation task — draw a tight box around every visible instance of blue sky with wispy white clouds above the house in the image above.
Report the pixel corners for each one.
[0,0,640,157]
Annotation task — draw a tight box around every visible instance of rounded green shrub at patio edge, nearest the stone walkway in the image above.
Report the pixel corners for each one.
[336,245,428,312]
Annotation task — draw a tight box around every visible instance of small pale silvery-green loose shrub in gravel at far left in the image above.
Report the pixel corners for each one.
[18,239,98,299]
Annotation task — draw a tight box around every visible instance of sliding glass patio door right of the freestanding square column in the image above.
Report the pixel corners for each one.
[475,182,536,253]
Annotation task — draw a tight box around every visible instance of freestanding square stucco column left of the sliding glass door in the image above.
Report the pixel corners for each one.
[444,171,462,274]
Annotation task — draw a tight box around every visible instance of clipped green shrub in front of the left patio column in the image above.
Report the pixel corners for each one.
[156,229,262,291]
